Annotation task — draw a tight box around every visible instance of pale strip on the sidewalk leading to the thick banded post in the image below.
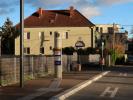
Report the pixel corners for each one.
[17,79,61,100]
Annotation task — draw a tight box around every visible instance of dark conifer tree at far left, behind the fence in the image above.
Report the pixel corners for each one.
[0,18,19,54]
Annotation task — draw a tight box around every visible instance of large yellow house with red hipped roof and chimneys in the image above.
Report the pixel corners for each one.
[15,7,95,55]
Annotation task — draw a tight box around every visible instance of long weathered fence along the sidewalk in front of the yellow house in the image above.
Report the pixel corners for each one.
[0,54,100,85]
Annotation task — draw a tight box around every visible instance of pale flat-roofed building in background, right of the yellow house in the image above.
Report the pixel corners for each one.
[96,24,128,50]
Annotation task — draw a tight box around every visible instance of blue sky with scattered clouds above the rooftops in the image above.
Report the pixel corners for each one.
[0,0,133,37]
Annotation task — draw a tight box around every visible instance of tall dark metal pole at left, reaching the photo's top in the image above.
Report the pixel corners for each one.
[20,0,24,88]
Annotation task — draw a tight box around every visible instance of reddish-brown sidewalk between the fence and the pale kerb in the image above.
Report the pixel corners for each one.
[0,71,101,100]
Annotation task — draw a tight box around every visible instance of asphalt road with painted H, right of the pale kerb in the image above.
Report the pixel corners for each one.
[66,66,133,100]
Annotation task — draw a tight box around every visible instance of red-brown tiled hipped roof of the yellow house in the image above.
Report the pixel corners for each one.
[17,9,94,28]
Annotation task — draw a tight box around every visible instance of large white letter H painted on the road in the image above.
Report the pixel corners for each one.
[100,87,119,98]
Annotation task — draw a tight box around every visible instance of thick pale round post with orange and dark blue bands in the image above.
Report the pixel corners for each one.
[54,32,62,79]
